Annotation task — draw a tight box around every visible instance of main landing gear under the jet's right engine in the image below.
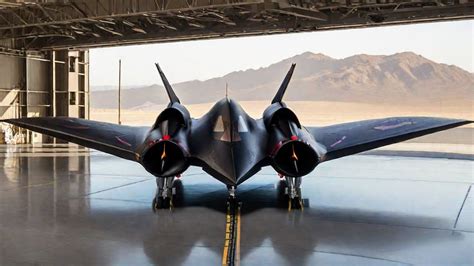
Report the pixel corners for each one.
[278,176,304,211]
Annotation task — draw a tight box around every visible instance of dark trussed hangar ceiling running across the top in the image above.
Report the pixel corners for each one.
[0,0,474,50]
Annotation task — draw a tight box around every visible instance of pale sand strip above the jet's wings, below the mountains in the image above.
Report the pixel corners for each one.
[91,101,474,126]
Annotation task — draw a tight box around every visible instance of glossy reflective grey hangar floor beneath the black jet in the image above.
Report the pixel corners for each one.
[0,146,474,265]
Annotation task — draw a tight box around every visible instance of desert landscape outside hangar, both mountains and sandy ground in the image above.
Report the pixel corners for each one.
[90,52,474,155]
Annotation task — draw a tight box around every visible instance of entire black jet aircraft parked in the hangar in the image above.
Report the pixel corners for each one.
[4,64,472,210]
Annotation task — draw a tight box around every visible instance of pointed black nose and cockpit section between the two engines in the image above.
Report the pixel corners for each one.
[192,99,266,185]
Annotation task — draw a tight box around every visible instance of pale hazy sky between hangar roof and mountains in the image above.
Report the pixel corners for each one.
[90,20,474,86]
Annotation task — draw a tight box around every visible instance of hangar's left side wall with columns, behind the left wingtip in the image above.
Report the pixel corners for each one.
[0,50,89,143]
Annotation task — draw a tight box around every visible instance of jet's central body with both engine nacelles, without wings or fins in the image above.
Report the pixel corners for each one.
[140,98,324,186]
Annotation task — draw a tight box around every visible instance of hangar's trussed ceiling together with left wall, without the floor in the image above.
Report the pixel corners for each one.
[0,0,474,143]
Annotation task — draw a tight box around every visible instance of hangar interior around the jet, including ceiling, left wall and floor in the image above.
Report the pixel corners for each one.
[0,0,474,265]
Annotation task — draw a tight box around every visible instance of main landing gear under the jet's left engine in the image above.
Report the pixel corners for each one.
[152,176,182,211]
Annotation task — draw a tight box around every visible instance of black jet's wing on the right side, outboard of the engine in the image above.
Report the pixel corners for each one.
[308,117,473,161]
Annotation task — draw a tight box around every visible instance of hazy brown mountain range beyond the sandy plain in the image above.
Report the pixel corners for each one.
[91,52,474,109]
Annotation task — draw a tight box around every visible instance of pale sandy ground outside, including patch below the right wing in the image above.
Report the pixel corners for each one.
[91,101,474,159]
